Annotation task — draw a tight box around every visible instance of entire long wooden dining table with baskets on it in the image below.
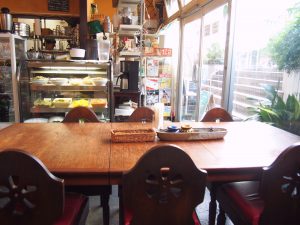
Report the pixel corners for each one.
[0,122,300,224]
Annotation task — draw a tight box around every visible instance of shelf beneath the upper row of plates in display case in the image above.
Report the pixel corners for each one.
[31,84,107,92]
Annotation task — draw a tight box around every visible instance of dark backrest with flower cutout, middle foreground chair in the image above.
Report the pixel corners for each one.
[122,145,206,225]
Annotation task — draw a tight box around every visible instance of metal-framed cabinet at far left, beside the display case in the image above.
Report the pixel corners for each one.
[0,33,26,122]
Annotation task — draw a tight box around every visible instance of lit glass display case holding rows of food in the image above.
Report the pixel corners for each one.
[22,61,113,122]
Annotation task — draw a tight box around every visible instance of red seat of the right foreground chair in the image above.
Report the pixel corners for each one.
[217,181,264,225]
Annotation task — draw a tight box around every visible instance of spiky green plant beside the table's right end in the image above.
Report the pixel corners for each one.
[251,85,300,135]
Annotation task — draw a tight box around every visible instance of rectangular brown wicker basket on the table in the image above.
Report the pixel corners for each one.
[111,129,156,142]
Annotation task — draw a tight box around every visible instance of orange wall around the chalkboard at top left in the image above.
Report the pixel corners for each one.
[0,0,80,17]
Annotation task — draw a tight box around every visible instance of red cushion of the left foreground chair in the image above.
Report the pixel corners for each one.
[54,193,87,225]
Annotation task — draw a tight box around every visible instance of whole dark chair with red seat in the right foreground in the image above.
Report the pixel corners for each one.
[217,143,300,225]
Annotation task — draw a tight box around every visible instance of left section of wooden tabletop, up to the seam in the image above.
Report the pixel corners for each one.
[0,123,111,185]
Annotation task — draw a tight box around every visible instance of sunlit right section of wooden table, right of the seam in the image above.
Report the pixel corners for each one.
[110,122,300,184]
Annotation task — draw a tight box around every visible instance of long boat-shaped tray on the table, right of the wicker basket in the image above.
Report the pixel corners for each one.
[156,128,227,141]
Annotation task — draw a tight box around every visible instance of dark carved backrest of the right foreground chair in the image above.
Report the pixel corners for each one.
[260,142,300,225]
